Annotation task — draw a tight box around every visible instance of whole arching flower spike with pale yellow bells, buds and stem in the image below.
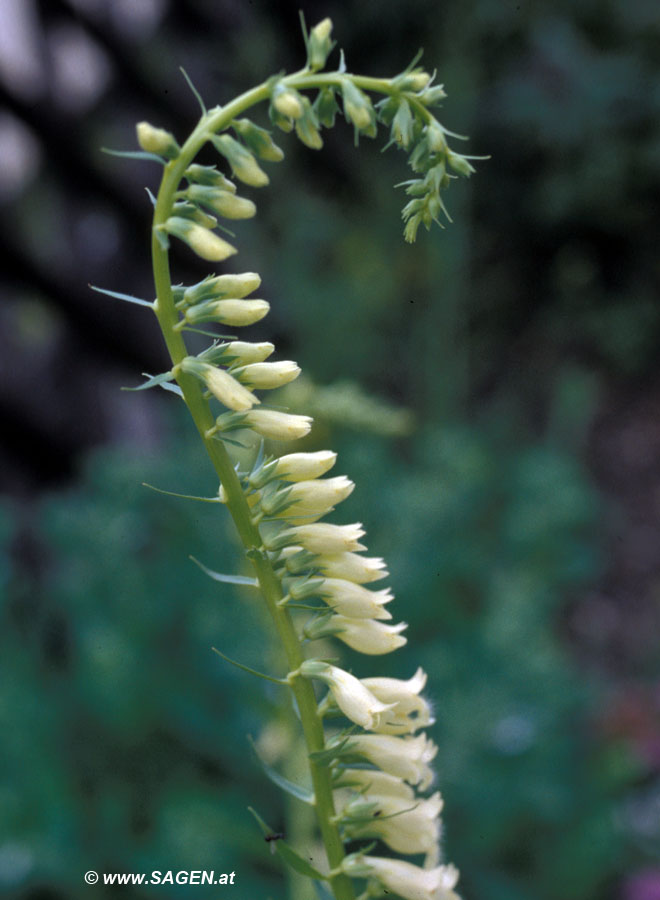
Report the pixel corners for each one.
[118,19,473,900]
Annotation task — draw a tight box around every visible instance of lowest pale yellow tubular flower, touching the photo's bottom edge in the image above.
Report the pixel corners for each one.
[342,855,459,900]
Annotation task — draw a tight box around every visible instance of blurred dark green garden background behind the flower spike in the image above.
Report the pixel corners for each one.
[0,0,660,900]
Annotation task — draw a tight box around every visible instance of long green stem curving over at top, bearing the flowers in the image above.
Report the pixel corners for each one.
[152,71,408,900]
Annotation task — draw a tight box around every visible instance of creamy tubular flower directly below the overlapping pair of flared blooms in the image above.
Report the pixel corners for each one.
[350,734,438,791]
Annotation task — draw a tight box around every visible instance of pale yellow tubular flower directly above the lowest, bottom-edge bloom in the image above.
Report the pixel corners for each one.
[348,791,443,855]
